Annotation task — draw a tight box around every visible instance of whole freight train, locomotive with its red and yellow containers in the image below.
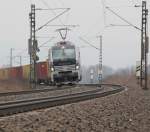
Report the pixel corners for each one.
[0,41,81,84]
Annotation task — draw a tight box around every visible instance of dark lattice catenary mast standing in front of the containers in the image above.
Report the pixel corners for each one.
[28,4,39,89]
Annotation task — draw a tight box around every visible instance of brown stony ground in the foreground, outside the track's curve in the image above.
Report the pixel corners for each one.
[0,76,150,132]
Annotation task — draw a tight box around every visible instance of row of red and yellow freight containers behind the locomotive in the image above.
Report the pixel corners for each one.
[0,61,51,84]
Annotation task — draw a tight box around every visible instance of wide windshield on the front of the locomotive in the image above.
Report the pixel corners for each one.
[52,48,76,65]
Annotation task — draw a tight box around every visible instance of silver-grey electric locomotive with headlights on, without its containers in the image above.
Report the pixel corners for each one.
[49,41,81,84]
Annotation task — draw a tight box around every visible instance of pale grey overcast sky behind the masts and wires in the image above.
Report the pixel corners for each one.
[0,0,150,69]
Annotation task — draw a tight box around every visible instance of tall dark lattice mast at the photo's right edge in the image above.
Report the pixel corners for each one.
[140,1,149,89]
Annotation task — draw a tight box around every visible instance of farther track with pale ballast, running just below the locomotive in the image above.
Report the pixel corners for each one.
[0,85,102,103]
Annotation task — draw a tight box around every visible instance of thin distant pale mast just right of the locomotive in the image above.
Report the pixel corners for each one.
[98,36,103,85]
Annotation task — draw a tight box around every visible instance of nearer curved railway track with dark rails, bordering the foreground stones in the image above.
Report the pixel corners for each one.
[0,84,125,117]
